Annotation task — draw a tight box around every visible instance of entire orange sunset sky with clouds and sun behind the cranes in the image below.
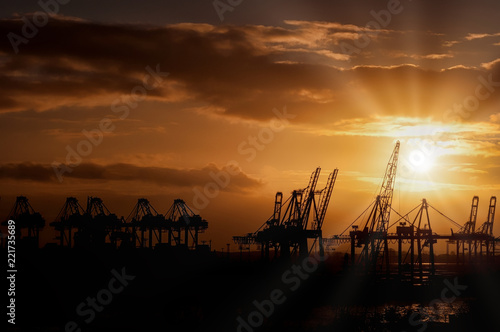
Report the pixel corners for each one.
[0,0,500,249]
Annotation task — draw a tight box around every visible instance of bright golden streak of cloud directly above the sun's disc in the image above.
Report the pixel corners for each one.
[294,116,500,160]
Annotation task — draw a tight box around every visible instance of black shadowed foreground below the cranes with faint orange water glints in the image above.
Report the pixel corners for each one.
[2,248,500,332]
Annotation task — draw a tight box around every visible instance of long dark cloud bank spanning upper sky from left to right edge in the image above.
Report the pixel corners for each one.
[0,17,500,122]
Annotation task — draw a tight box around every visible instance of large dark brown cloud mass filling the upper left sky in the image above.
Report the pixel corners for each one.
[0,19,352,118]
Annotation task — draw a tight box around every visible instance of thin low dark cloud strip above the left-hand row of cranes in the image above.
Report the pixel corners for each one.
[0,162,262,192]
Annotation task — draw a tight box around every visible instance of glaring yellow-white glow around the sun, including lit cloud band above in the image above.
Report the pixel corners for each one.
[295,116,500,193]
